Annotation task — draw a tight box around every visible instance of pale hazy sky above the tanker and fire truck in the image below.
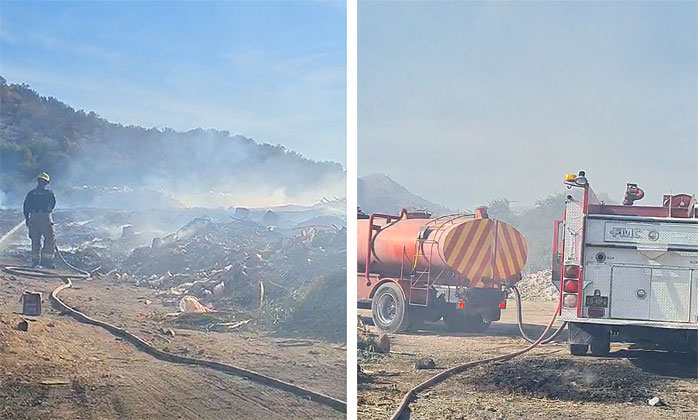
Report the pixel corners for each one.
[358,2,698,209]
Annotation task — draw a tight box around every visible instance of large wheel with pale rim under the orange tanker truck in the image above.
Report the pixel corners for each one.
[372,282,409,333]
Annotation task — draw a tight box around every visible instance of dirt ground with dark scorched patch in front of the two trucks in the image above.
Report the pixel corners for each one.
[357,301,698,420]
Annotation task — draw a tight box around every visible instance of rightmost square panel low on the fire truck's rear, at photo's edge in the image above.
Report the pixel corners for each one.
[649,268,691,322]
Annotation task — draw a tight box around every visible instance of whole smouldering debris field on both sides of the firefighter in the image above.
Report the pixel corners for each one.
[2,210,346,340]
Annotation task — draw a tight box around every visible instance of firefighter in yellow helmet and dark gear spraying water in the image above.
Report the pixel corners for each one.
[24,172,56,268]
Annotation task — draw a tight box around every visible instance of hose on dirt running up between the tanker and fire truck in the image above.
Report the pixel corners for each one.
[391,284,566,420]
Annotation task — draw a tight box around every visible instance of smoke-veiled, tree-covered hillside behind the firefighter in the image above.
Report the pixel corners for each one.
[0,77,345,207]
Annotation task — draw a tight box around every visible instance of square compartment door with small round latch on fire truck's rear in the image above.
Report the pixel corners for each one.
[610,266,651,320]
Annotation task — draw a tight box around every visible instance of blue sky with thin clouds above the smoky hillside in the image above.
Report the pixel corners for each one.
[0,1,346,164]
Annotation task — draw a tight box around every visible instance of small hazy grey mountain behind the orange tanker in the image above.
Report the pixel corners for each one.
[357,174,450,215]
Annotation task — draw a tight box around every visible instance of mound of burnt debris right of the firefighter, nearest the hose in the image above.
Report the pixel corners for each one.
[122,217,346,338]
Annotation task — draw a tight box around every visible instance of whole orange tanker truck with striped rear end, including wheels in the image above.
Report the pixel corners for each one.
[357,207,527,332]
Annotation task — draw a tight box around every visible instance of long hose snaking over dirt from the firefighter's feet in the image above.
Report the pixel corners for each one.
[3,236,347,413]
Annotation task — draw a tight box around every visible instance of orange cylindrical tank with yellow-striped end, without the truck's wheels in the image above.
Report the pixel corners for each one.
[357,208,527,287]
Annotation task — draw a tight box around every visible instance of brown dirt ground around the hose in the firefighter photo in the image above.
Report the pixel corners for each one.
[0,261,346,420]
